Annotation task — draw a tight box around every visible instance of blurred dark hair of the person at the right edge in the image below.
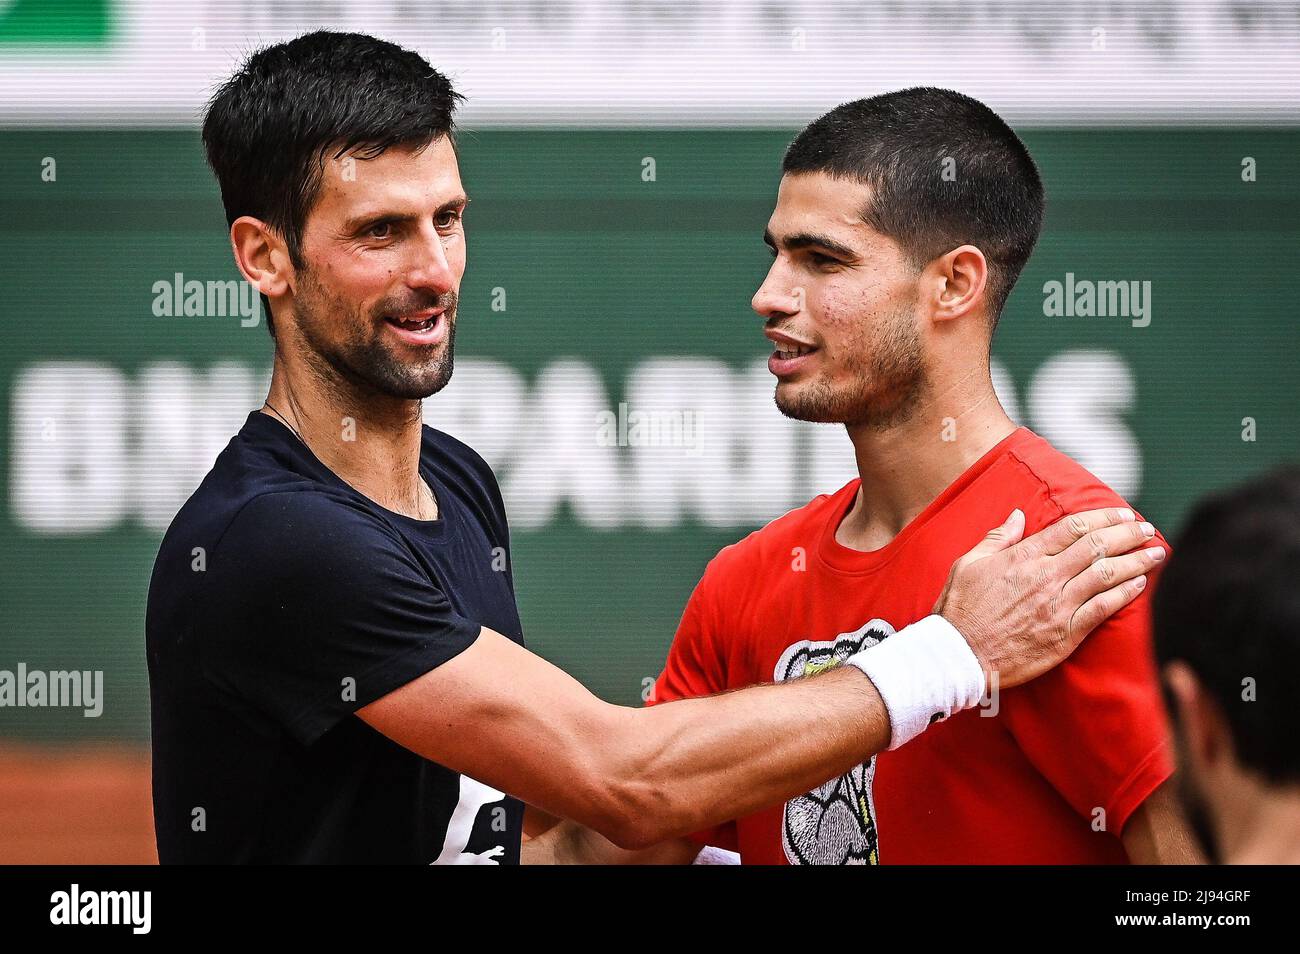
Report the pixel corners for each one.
[1153,465,1300,784]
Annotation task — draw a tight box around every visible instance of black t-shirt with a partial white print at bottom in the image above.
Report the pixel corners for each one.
[146,411,523,864]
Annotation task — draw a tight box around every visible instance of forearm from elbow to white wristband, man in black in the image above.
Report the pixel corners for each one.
[603,667,889,847]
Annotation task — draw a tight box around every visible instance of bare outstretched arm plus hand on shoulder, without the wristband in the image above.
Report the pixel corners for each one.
[358,509,1153,849]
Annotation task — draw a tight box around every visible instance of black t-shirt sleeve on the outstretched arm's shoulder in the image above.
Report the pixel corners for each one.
[198,491,480,745]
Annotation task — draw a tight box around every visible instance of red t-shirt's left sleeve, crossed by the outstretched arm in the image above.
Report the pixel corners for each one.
[646,556,740,851]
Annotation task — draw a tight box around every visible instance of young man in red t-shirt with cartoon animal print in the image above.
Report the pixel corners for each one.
[525,88,1199,864]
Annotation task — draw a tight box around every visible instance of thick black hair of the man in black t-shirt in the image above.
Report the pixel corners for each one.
[203,31,462,334]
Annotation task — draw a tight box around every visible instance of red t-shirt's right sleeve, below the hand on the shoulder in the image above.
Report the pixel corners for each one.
[1001,514,1174,836]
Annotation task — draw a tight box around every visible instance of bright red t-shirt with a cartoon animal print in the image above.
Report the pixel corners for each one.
[653,428,1173,864]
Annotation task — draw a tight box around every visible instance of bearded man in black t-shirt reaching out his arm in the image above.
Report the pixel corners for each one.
[146,32,1151,864]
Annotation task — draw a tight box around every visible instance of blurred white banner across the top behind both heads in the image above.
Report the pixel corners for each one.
[0,0,1300,127]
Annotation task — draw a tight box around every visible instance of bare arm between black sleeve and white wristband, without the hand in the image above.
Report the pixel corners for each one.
[359,629,889,847]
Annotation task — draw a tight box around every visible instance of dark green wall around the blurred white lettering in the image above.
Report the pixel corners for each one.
[0,129,1300,741]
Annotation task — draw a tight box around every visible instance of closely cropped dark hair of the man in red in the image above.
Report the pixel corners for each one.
[781,86,1044,325]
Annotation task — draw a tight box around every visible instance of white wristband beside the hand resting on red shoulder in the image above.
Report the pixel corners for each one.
[846,616,984,749]
